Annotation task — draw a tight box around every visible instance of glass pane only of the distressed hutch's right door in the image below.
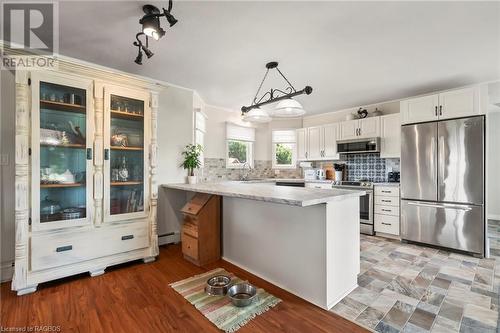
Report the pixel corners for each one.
[110,95,144,215]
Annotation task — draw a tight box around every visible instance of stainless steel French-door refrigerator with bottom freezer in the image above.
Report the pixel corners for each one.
[401,116,485,256]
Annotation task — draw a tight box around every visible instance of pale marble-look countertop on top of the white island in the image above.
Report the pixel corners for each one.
[161,181,366,207]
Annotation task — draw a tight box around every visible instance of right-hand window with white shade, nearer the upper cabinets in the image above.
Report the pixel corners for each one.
[272,130,297,169]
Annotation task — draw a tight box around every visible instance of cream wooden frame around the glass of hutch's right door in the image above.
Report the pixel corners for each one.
[104,84,151,223]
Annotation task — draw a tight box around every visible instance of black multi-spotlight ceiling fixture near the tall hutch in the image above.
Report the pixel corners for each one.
[134,0,178,65]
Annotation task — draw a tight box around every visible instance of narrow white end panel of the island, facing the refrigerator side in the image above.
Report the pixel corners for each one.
[326,198,360,309]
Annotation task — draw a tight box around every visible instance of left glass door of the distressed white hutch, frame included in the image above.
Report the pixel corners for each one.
[32,72,93,229]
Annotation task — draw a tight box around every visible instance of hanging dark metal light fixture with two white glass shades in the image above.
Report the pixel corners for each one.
[241,61,312,122]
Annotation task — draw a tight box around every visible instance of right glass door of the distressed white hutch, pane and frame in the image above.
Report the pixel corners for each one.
[104,85,148,221]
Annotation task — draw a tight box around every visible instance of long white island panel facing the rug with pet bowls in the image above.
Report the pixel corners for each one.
[222,197,328,308]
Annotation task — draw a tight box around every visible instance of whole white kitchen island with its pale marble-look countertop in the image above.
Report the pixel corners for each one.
[162,181,364,309]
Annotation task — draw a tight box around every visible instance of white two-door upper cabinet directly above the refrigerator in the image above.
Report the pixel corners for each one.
[400,86,481,124]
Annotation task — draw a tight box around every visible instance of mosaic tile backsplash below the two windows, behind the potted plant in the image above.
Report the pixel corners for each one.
[198,158,302,182]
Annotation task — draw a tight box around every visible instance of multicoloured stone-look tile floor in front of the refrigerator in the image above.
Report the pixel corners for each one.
[332,221,500,333]
